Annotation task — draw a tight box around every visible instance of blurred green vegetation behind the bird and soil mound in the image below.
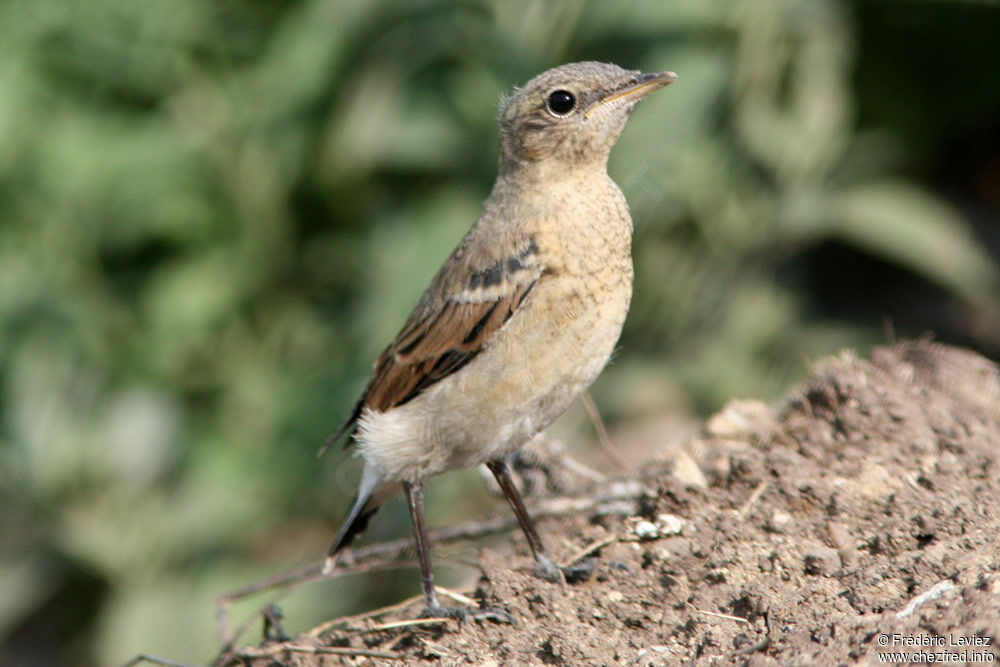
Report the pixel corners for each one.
[0,0,1000,665]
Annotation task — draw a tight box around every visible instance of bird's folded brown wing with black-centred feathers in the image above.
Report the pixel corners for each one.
[320,232,542,454]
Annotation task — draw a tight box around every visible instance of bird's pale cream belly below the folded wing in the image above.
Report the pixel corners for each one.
[358,280,630,480]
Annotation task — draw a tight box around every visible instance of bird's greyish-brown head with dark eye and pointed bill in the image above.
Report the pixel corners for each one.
[500,62,677,171]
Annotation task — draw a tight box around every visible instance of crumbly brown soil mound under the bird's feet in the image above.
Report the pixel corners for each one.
[225,341,1000,665]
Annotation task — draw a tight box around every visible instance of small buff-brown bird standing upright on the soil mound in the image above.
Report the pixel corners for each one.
[320,62,677,619]
